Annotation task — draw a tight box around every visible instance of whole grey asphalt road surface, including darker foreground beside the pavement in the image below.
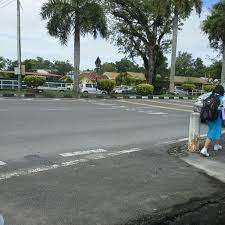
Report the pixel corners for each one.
[0,99,222,225]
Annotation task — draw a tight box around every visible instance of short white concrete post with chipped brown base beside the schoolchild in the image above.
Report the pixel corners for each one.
[188,113,200,152]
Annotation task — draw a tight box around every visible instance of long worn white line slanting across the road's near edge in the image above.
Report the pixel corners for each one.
[0,148,142,180]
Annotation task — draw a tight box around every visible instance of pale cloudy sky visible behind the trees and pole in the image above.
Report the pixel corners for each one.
[0,0,220,70]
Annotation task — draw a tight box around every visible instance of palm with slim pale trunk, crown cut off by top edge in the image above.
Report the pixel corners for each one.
[170,0,202,93]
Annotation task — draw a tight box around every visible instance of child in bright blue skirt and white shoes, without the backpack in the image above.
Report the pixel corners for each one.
[200,85,224,157]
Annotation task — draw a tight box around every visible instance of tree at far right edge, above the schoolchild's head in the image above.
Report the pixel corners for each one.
[202,0,225,83]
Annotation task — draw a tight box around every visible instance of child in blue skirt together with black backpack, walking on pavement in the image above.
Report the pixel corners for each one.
[200,85,224,157]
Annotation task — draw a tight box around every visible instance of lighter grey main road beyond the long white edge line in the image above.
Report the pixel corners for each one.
[0,99,197,161]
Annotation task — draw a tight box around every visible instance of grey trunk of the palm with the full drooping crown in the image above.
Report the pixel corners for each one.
[74,25,80,92]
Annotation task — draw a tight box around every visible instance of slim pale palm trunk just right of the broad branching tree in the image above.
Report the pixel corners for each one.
[170,10,179,93]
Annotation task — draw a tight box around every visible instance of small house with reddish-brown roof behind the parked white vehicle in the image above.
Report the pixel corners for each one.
[79,72,108,84]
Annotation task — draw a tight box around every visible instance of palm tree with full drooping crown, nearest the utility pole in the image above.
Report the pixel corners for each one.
[41,0,107,91]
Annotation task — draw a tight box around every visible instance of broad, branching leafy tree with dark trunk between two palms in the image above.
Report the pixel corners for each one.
[107,0,172,83]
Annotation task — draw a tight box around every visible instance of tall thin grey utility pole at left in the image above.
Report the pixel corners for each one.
[17,0,22,90]
